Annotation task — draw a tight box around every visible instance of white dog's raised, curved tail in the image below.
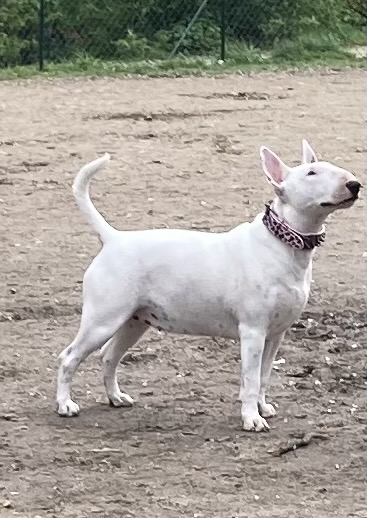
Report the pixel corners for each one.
[73,153,116,242]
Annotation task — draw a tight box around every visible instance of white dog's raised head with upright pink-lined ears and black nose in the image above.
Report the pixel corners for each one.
[260,140,361,221]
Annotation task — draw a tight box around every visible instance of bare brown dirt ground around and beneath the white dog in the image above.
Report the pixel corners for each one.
[0,71,366,518]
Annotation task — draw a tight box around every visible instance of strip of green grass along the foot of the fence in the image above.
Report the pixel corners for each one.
[0,37,366,80]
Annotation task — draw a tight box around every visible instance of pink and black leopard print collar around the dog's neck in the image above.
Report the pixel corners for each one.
[263,203,325,250]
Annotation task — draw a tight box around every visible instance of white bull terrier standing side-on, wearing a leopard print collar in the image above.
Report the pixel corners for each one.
[56,140,361,432]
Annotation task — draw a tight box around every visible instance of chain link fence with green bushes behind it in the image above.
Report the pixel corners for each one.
[0,0,366,68]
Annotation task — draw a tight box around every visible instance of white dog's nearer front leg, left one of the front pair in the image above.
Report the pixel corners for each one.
[239,324,269,432]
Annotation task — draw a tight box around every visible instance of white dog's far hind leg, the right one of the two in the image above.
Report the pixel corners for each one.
[101,318,149,407]
